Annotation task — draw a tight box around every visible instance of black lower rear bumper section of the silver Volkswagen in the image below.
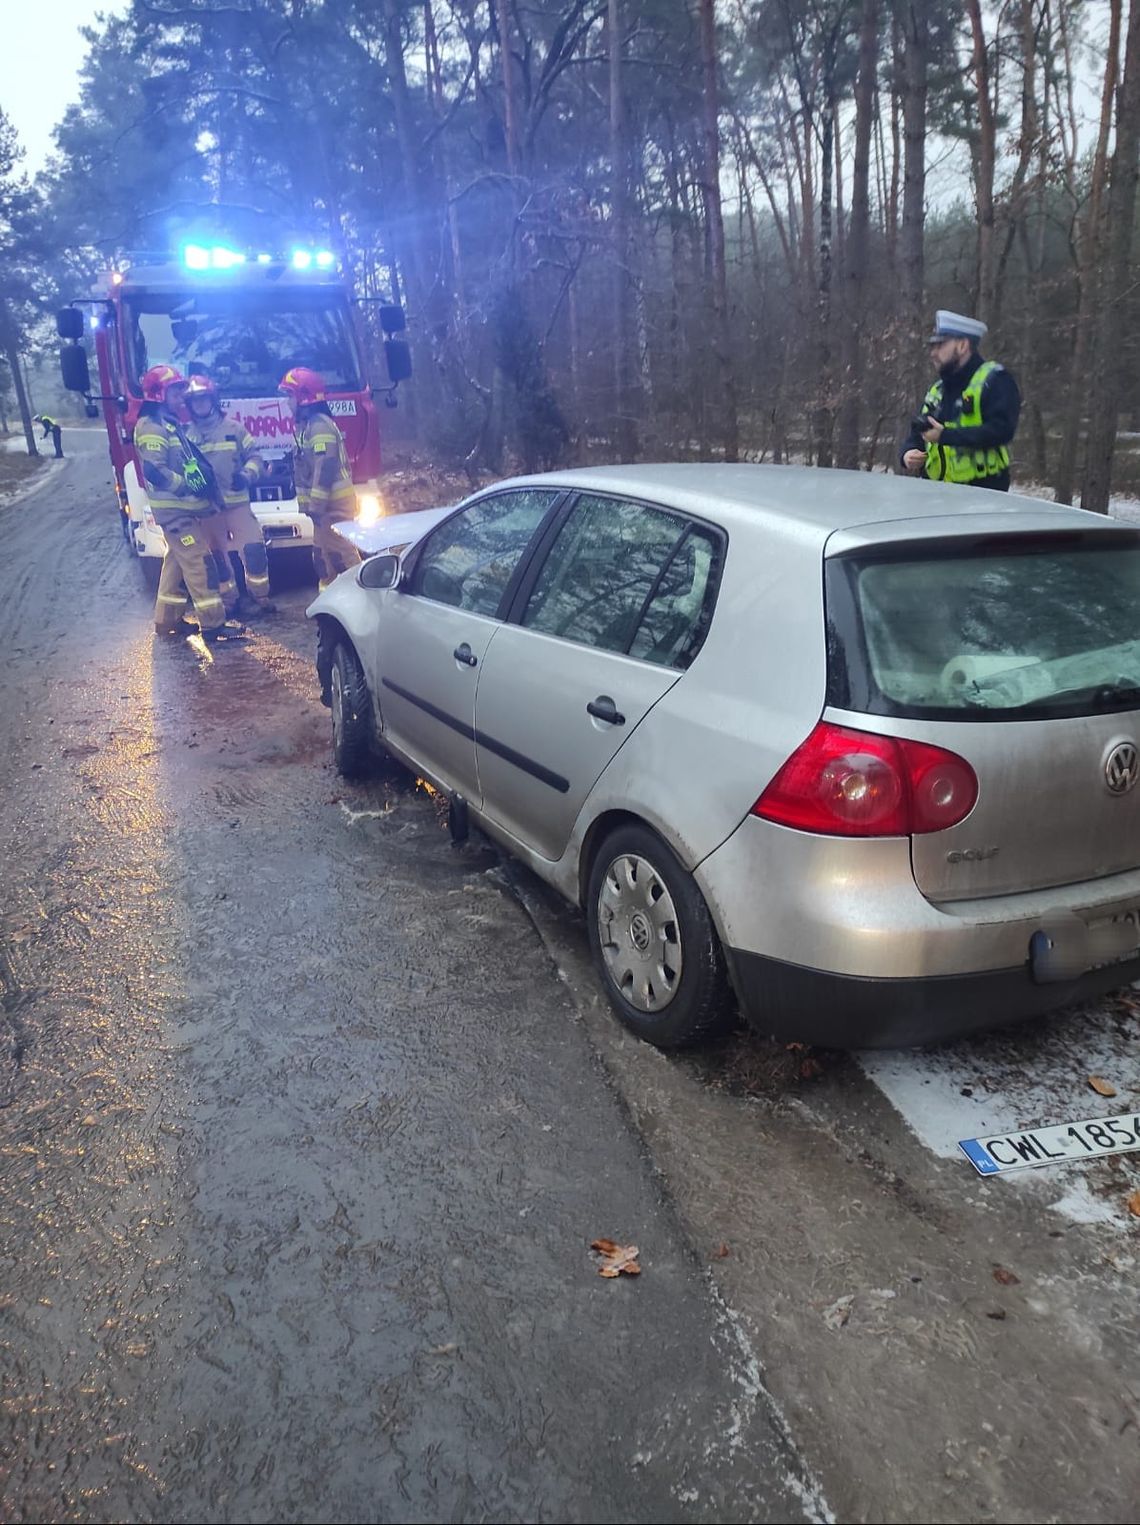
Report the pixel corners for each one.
[725,949,1140,1049]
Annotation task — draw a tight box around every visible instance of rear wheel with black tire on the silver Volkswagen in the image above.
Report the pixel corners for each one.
[585,825,736,1049]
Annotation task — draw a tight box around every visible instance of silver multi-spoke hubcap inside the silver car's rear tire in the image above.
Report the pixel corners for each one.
[597,852,683,1013]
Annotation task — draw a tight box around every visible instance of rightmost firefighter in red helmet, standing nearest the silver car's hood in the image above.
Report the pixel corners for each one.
[277,366,360,587]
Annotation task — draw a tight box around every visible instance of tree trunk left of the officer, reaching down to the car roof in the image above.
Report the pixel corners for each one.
[837,0,879,470]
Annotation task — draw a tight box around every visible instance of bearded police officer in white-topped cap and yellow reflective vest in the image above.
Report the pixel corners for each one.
[899,310,1021,493]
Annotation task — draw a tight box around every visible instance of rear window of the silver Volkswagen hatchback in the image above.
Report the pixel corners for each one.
[826,531,1140,720]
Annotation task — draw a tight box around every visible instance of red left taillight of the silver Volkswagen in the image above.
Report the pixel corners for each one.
[751,720,978,837]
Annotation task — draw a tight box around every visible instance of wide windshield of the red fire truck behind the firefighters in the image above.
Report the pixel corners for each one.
[125,290,361,397]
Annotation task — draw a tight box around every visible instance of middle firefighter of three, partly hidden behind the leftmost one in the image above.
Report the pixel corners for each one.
[186,374,277,619]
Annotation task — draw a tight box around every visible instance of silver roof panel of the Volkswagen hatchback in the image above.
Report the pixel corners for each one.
[491,462,1120,541]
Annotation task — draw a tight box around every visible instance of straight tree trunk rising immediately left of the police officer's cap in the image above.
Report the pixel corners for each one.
[896,0,930,407]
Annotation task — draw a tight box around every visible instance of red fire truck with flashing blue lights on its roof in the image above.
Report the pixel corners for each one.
[56,242,411,583]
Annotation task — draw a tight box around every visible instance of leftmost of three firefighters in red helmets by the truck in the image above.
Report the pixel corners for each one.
[134,366,241,644]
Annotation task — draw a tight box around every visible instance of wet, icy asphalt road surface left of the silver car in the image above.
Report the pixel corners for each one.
[0,432,821,1522]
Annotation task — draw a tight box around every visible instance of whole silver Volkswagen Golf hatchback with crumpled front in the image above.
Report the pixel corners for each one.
[309,465,1140,1048]
